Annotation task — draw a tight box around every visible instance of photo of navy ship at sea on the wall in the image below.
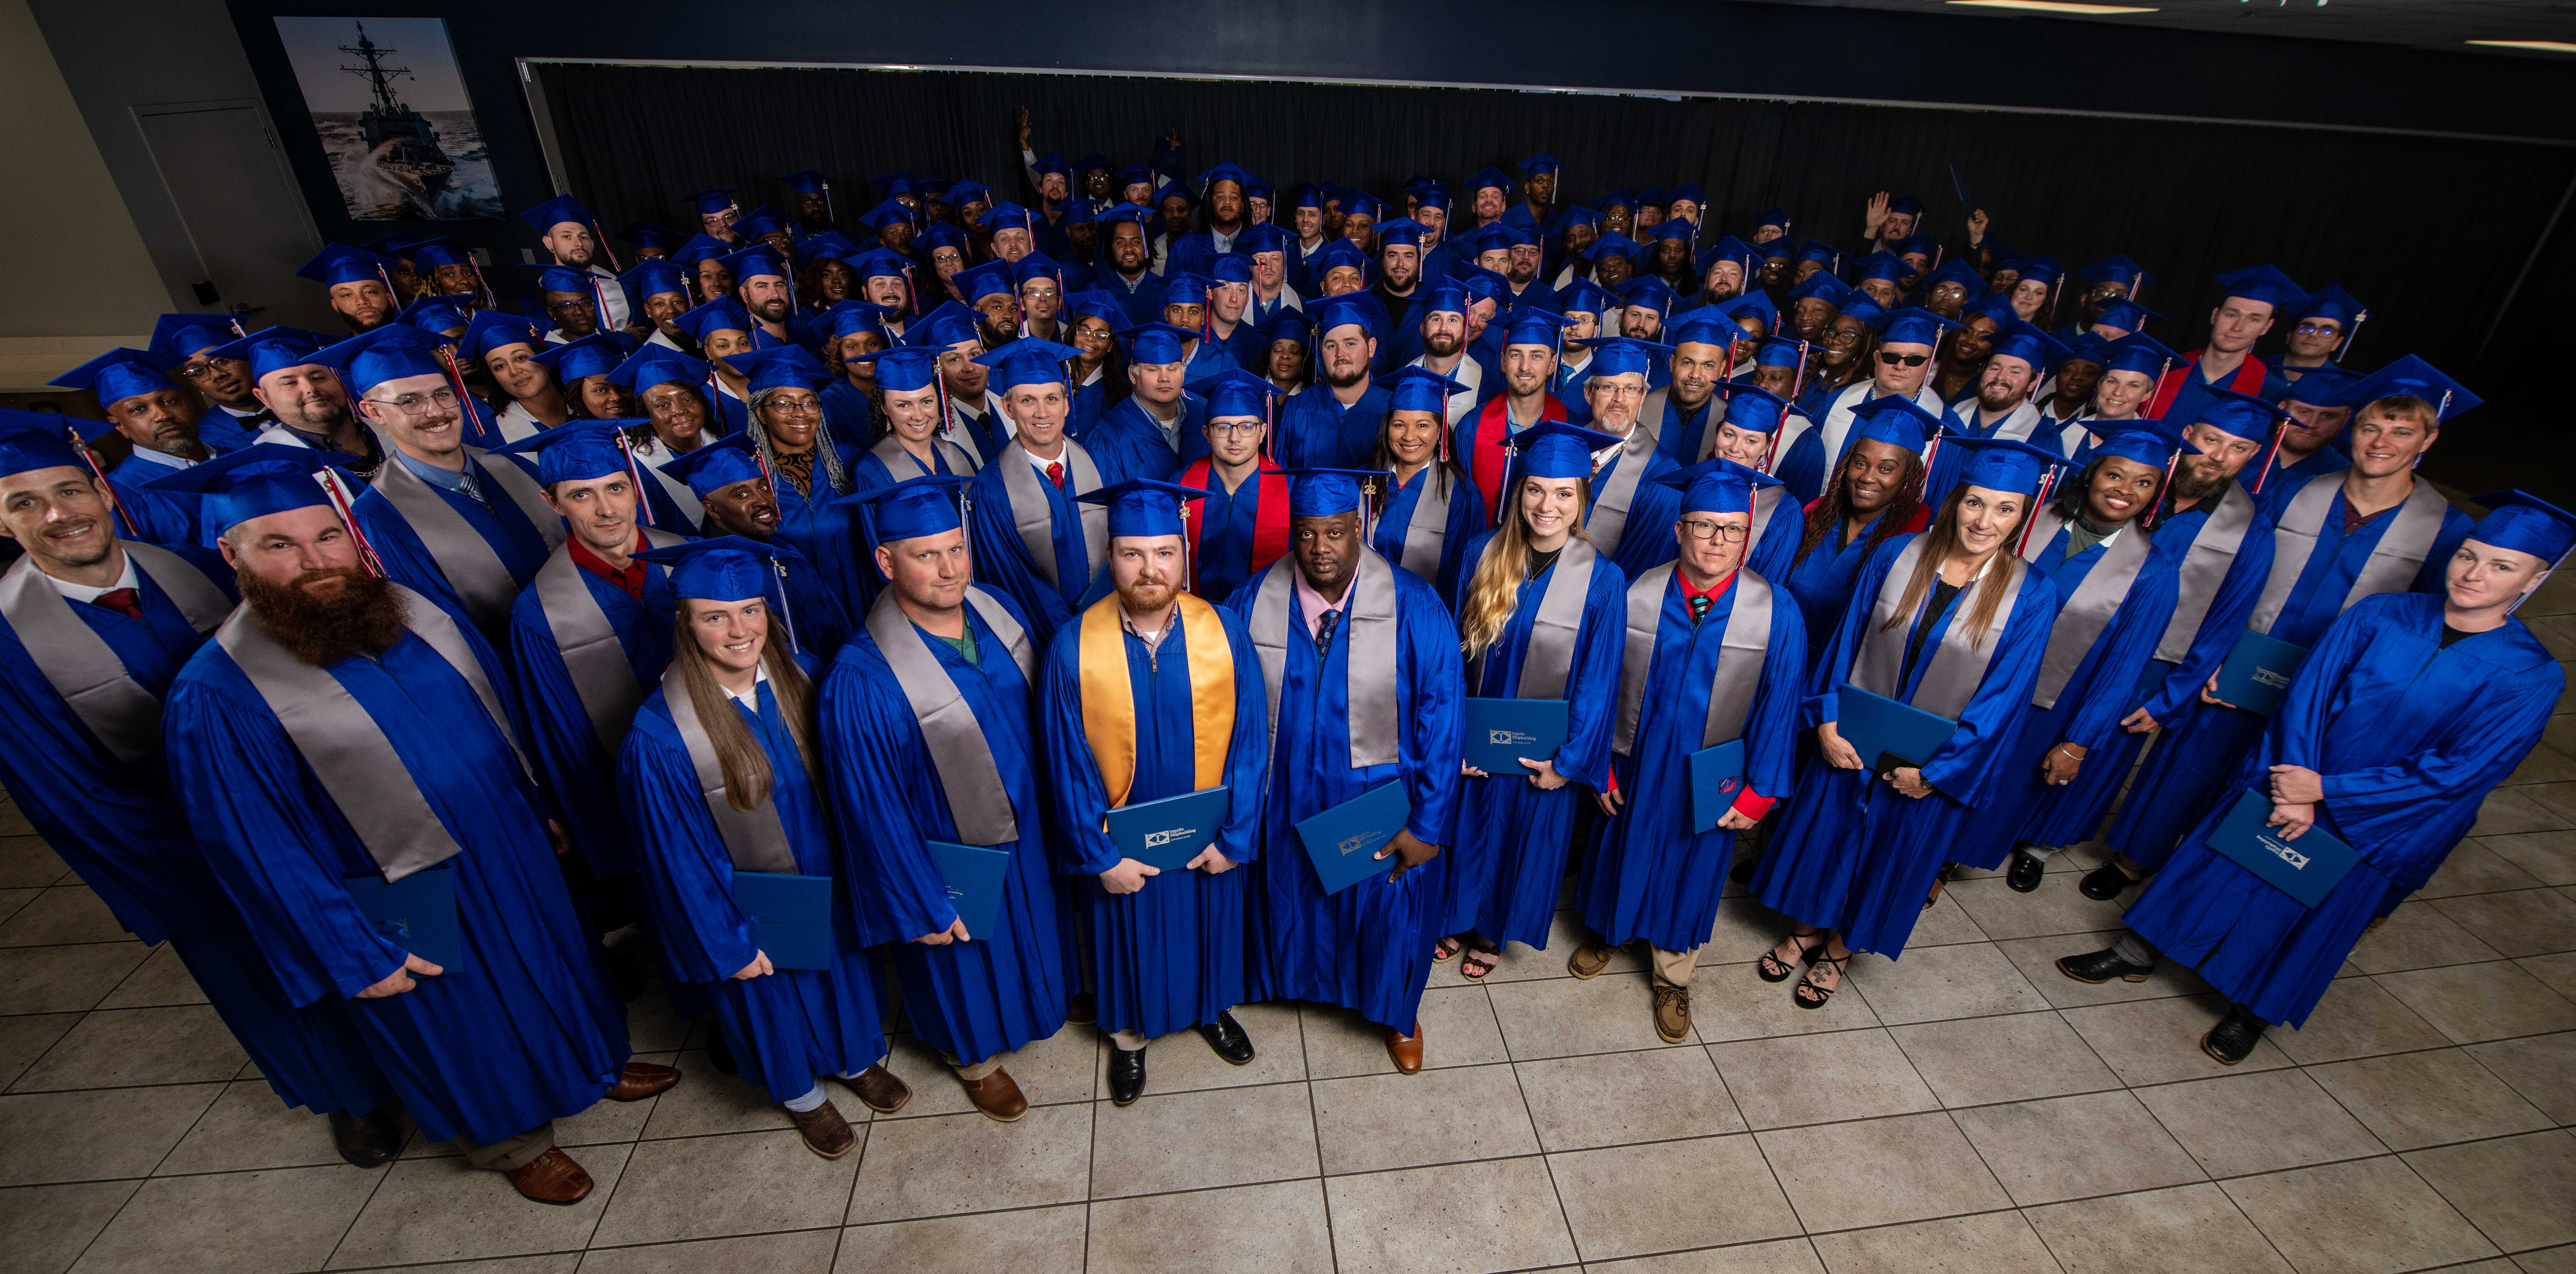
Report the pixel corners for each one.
[276,18,502,222]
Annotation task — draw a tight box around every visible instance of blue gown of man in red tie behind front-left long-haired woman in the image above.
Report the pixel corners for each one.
[510,562,675,877]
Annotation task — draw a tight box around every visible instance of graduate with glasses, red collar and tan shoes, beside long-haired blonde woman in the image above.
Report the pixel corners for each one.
[1566,459,1806,1044]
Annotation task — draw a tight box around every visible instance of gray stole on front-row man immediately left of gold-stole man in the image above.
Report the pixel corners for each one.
[868,585,1033,846]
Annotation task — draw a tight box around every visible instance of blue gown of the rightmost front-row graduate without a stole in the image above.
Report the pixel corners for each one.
[2128,593,2566,1026]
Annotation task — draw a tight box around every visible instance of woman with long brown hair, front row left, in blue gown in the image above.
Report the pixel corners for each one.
[616,536,912,1158]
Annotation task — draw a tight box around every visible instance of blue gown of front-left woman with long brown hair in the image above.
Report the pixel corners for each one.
[618,655,886,1101]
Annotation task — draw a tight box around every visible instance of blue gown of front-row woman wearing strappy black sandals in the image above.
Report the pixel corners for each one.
[1754,534,2058,959]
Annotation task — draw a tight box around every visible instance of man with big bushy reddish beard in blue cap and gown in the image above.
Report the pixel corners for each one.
[162,449,680,1204]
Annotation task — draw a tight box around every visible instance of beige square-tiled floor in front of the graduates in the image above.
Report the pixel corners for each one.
[0,580,2576,1274]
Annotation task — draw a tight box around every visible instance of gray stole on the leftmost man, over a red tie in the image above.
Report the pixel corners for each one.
[0,539,232,766]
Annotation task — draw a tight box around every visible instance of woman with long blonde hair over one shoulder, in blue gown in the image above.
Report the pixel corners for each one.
[1432,420,1618,980]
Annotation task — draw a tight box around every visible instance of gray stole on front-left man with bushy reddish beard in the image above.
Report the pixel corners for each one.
[214,583,528,882]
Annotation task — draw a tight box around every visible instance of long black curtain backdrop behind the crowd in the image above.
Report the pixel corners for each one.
[536,61,2576,379]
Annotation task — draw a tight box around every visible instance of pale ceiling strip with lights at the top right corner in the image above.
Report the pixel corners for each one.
[1770,0,2576,55]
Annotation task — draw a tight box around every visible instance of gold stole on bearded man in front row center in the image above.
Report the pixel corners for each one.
[1074,593,1234,810]
